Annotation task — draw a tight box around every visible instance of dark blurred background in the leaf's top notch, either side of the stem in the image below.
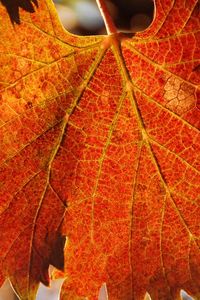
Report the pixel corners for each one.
[54,0,154,35]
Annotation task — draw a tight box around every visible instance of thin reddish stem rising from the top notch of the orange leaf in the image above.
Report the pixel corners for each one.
[96,0,117,34]
